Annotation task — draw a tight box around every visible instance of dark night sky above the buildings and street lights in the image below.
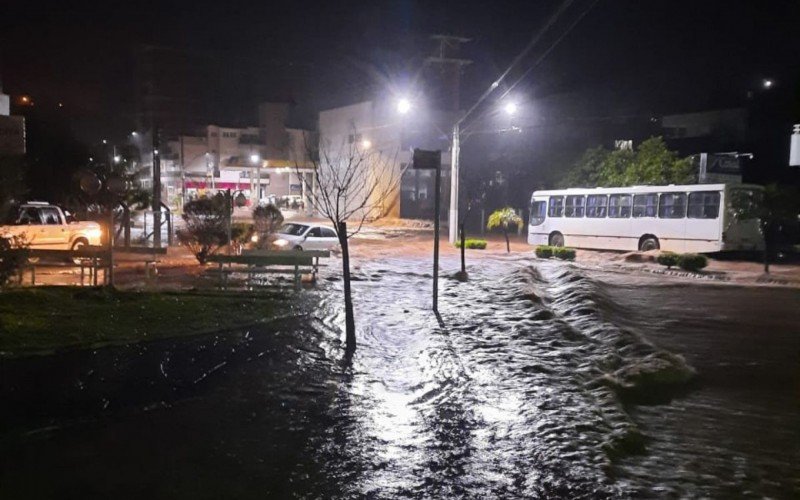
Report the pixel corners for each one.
[0,0,800,141]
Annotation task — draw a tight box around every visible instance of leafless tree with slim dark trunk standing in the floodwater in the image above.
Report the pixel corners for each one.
[295,130,401,351]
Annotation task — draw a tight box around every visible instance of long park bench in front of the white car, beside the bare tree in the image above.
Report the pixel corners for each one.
[208,250,331,289]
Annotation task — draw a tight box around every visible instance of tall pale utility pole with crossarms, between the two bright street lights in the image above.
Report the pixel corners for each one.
[425,35,472,243]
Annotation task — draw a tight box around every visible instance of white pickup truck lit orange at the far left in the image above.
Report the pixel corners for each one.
[0,202,103,250]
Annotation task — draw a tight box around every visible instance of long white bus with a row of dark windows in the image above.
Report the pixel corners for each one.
[528,184,764,252]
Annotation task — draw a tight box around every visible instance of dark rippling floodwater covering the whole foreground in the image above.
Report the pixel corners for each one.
[0,257,800,498]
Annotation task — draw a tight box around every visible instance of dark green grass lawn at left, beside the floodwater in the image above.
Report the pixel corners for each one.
[0,287,289,356]
